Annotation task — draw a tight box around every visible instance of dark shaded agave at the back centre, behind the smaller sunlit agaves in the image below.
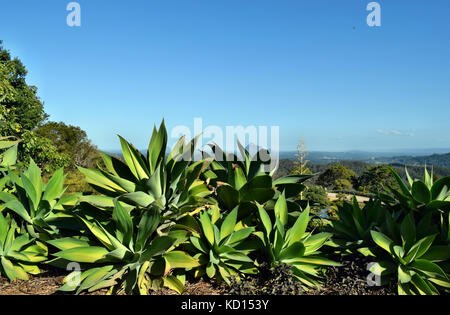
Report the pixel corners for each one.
[204,141,313,219]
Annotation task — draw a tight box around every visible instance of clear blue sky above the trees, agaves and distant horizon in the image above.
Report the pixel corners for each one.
[0,0,450,150]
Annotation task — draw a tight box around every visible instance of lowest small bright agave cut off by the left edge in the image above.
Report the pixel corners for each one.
[0,212,48,281]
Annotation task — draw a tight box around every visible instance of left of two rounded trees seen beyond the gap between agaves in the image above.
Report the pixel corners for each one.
[317,164,357,190]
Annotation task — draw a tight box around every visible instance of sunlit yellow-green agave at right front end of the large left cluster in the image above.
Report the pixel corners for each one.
[255,193,340,288]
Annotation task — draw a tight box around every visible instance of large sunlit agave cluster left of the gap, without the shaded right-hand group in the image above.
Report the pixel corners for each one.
[0,122,335,294]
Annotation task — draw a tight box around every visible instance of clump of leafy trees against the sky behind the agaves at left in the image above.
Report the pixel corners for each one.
[0,41,98,173]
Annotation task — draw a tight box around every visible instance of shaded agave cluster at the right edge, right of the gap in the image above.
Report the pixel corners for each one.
[330,168,450,295]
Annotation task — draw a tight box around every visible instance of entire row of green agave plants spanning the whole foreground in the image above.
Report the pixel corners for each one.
[0,122,450,294]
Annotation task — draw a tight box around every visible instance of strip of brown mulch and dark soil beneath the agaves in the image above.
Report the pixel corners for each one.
[0,257,395,295]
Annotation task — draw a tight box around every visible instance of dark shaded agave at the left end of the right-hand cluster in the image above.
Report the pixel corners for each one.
[328,197,387,252]
